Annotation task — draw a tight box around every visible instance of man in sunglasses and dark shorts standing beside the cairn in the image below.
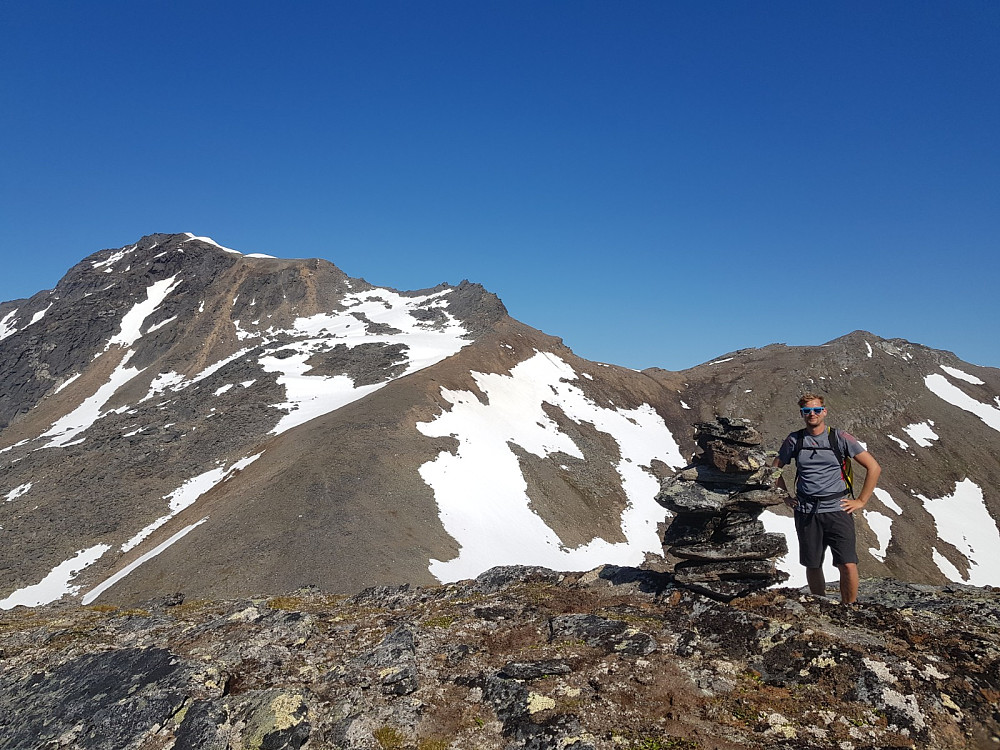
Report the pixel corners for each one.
[773,393,882,604]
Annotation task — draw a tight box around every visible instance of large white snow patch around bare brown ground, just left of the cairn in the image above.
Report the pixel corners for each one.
[417,352,685,581]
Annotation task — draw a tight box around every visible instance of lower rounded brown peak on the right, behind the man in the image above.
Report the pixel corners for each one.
[647,331,1000,585]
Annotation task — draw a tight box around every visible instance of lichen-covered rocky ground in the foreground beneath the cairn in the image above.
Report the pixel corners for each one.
[0,567,1000,750]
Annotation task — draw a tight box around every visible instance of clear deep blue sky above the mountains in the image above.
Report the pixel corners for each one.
[0,0,1000,369]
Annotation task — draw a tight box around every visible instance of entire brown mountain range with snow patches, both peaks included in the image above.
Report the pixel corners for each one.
[0,234,1000,608]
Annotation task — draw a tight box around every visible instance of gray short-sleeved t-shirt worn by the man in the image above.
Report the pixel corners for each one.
[778,430,865,513]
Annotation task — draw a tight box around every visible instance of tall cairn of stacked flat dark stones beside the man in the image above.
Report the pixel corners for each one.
[656,417,788,602]
